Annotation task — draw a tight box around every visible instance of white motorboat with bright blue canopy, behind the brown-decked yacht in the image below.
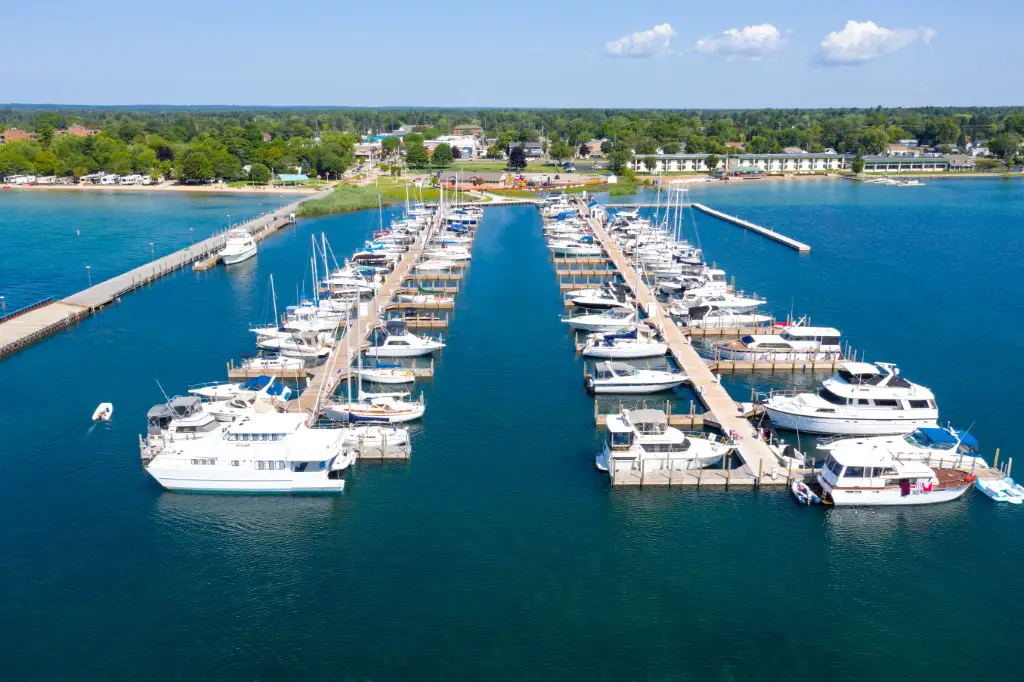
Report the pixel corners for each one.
[818,426,988,469]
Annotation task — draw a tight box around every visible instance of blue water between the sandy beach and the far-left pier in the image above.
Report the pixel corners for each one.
[0,190,292,312]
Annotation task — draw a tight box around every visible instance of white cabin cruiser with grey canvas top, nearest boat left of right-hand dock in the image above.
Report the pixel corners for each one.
[594,410,731,477]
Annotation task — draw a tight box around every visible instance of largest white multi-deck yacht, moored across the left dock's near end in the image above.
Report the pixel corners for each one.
[139,399,355,494]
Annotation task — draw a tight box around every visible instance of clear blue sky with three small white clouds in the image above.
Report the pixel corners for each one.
[0,0,1024,108]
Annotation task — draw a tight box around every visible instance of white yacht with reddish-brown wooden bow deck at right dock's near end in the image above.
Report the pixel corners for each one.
[816,451,975,507]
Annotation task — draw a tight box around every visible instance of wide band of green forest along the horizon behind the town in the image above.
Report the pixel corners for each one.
[0,106,1024,181]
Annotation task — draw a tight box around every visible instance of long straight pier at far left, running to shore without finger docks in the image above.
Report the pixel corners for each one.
[0,186,329,357]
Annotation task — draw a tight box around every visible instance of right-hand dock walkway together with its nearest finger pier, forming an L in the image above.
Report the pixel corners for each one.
[581,196,784,485]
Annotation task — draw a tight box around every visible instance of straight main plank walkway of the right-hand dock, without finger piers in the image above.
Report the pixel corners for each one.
[580,196,779,479]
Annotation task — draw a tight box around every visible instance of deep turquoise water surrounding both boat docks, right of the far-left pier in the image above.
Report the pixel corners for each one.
[0,182,1024,682]
